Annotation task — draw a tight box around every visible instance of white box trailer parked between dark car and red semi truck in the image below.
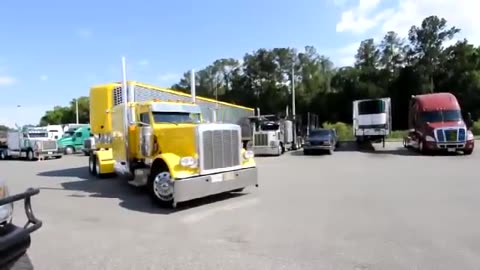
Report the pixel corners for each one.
[353,98,392,147]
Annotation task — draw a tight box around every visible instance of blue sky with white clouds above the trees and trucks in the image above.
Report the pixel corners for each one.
[0,0,480,126]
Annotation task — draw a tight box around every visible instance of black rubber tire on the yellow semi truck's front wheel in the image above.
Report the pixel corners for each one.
[148,166,173,209]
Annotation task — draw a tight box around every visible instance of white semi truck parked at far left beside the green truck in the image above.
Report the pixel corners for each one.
[0,127,62,160]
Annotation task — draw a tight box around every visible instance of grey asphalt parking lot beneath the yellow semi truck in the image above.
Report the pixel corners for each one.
[0,143,480,270]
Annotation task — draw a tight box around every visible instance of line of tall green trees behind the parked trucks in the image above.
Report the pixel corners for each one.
[41,16,480,132]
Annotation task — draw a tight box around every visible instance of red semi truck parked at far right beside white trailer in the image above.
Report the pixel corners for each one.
[404,93,475,155]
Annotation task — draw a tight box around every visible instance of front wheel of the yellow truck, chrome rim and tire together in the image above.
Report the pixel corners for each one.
[148,166,173,208]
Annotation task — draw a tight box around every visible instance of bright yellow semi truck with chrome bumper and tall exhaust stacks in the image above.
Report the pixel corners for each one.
[88,59,258,207]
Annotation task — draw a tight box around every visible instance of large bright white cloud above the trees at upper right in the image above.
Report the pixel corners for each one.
[334,0,480,66]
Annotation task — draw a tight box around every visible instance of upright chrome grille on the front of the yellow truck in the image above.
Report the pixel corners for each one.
[202,129,241,170]
